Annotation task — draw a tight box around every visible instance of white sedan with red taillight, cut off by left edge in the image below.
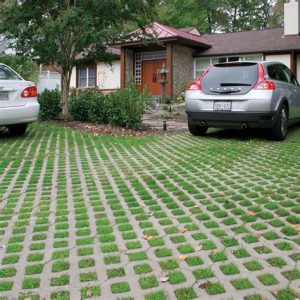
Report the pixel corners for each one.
[0,63,40,135]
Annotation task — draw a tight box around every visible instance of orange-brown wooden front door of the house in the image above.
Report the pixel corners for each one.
[142,59,166,96]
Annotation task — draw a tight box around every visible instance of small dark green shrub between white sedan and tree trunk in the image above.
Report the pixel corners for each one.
[38,89,61,120]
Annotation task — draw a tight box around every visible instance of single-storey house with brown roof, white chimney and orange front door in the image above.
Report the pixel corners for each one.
[71,0,300,97]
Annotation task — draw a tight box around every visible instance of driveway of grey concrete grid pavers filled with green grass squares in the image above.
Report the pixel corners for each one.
[0,124,300,300]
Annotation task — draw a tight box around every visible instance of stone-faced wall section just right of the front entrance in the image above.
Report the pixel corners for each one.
[172,45,194,97]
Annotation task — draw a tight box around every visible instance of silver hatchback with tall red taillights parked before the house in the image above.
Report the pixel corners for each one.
[185,61,300,140]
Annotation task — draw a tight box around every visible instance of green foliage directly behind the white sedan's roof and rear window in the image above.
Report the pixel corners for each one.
[0,54,39,83]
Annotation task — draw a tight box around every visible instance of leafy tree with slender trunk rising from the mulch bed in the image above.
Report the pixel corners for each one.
[0,0,156,117]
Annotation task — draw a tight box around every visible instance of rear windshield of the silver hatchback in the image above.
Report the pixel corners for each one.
[201,63,258,95]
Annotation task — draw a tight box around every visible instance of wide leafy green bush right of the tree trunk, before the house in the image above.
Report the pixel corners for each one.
[69,83,151,128]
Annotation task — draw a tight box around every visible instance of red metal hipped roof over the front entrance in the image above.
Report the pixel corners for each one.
[111,22,211,49]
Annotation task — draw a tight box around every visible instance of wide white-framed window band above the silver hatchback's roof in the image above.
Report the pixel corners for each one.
[194,54,263,79]
